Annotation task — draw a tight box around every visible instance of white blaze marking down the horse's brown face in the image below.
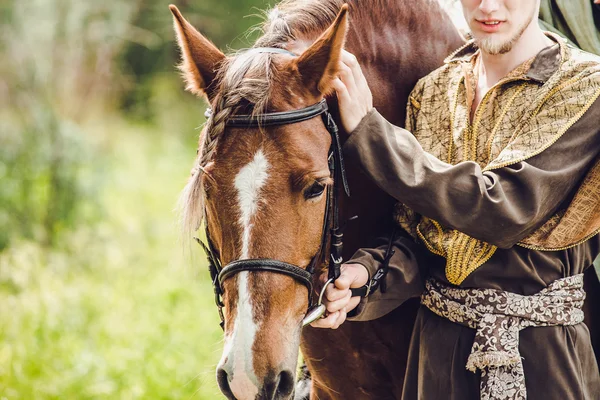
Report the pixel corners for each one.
[223,150,269,399]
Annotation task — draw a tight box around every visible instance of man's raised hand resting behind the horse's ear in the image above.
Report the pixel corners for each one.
[333,50,373,133]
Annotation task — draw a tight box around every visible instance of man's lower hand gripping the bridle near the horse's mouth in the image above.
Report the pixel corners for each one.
[310,264,369,329]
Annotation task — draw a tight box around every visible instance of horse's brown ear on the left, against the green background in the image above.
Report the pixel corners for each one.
[169,4,225,100]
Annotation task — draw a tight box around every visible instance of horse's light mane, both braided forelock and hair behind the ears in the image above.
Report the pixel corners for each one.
[179,0,446,237]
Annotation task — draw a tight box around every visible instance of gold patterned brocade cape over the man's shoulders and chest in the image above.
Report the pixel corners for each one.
[397,36,600,284]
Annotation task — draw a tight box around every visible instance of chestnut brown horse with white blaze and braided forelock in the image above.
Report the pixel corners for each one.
[170,0,600,400]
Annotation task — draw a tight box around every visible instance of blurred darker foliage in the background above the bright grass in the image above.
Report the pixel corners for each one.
[0,0,268,249]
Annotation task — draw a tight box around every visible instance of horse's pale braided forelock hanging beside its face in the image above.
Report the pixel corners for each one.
[179,51,274,237]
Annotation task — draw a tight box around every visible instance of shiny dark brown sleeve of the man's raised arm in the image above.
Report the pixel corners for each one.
[344,100,600,248]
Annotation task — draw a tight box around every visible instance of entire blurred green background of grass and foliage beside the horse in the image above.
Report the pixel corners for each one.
[0,0,266,399]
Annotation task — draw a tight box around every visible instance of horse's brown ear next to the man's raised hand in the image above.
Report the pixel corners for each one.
[296,4,348,95]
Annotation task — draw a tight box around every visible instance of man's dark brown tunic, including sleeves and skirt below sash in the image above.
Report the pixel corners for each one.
[344,39,600,400]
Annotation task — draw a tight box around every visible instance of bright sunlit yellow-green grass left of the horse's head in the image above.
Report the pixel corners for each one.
[0,119,222,400]
